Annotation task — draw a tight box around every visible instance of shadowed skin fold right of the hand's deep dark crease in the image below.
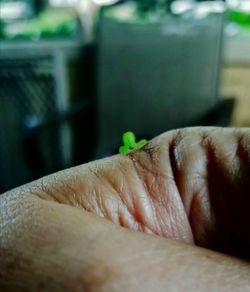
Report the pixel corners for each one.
[152,128,250,258]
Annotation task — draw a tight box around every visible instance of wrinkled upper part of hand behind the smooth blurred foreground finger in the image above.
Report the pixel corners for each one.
[7,128,250,257]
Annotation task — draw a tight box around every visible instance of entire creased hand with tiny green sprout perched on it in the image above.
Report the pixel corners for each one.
[0,128,250,292]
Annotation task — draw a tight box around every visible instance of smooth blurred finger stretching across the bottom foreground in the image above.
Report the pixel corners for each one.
[0,191,250,292]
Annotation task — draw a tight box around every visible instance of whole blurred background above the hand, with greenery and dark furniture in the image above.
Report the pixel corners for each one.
[0,0,250,192]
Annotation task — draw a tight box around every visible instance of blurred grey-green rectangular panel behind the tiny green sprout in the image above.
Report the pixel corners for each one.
[97,15,224,153]
